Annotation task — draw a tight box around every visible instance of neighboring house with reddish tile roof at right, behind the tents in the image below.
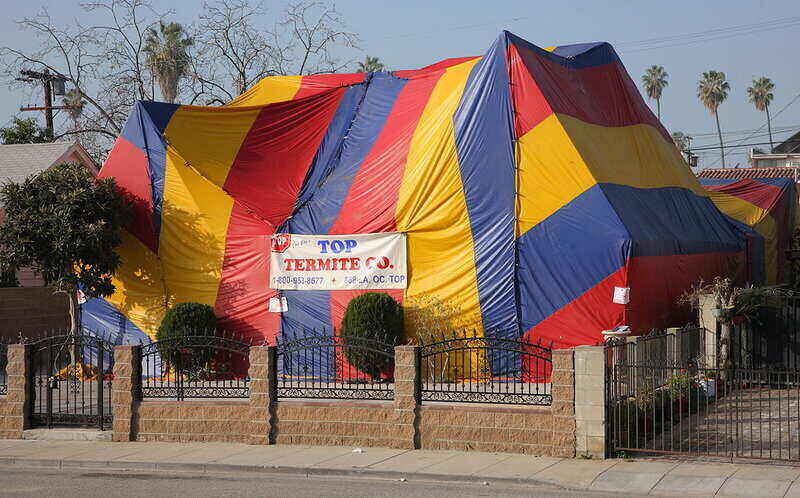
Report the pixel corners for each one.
[697,132,800,183]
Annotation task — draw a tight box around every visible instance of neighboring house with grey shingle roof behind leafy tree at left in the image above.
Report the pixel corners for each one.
[0,142,99,287]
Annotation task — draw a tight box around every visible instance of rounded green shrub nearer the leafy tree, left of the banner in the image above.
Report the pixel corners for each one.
[156,303,217,373]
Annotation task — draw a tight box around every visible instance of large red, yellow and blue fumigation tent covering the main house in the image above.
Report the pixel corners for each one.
[83,32,746,346]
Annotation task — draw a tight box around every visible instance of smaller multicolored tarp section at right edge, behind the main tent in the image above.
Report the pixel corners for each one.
[700,178,797,285]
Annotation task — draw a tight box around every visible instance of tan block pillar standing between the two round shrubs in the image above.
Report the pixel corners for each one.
[248,346,278,444]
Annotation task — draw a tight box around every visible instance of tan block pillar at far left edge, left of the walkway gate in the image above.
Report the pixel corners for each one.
[0,344,31,439]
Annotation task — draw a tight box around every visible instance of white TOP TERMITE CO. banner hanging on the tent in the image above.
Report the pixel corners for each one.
[269,233,408,290]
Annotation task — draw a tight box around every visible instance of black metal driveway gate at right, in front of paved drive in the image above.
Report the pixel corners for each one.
[606,329,800,461]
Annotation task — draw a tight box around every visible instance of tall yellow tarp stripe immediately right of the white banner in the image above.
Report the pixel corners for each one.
[395,60,482,335]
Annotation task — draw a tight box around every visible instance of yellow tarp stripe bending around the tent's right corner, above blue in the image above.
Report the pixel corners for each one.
[516,114,707,235]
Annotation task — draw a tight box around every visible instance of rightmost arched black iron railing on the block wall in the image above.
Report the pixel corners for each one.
[419,331,553,405]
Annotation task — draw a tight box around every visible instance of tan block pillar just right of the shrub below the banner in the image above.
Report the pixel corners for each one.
[394,346,422,449]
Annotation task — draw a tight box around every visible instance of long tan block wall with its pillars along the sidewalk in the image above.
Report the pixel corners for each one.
[0,346,605,457]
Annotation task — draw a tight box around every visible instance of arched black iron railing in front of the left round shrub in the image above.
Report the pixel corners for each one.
[139,331,251,401]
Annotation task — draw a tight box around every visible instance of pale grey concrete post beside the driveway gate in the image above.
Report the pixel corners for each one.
[575,346,606,458]
